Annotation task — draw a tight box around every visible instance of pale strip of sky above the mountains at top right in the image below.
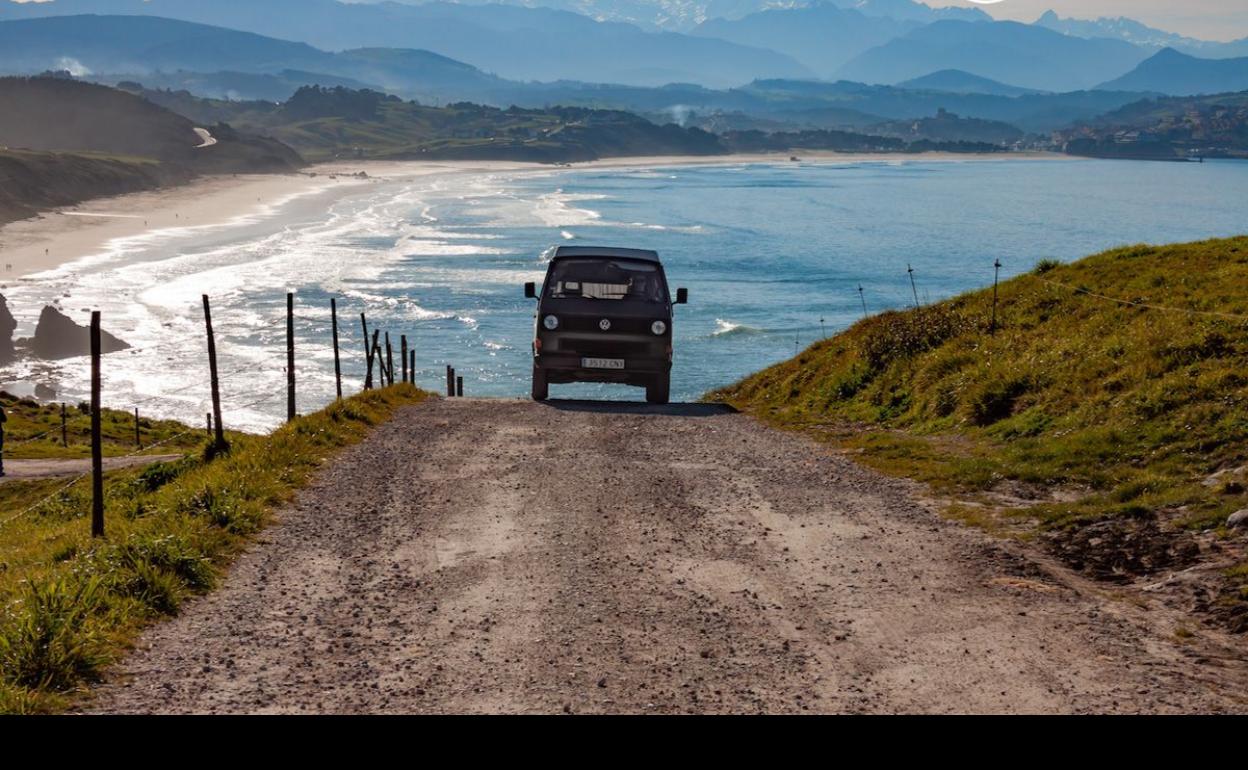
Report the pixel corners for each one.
[943,0,1248,40]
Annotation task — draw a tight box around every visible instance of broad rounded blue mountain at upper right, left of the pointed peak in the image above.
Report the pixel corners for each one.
[837,21,1148,91]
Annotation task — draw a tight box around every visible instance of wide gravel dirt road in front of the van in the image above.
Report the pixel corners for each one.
[89,399,1248,713]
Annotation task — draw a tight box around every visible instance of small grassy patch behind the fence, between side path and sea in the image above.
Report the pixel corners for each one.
[0,393,203,459]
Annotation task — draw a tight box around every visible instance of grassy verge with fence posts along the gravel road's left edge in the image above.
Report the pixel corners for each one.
[0,386,426,713]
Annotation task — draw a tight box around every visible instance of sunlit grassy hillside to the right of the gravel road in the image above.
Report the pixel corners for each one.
[711,237,1248,630]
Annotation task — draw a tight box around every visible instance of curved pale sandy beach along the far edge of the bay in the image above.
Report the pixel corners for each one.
[0,151,1078,279]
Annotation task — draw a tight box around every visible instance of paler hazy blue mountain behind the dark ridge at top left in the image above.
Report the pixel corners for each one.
[0,0,815,87]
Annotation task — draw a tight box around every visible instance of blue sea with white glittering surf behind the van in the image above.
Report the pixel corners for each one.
[0,158,1248,431]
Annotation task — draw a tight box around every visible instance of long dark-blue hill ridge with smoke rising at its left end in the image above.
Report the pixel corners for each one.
[0,16,1168,132]
